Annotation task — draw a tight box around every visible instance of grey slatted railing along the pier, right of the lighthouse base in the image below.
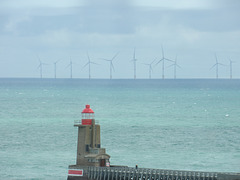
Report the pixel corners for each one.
[88,167,217,180]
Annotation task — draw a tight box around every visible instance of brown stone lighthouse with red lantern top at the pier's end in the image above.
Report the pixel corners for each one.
[71,105,110,167]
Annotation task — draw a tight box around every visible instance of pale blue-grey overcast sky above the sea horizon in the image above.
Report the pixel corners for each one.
[0,0,240,79]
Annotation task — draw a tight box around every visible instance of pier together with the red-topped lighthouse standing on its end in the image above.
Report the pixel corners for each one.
[68,105,240,180]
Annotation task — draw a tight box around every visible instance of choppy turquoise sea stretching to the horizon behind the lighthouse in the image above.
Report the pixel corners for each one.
[0,78,240,180]
